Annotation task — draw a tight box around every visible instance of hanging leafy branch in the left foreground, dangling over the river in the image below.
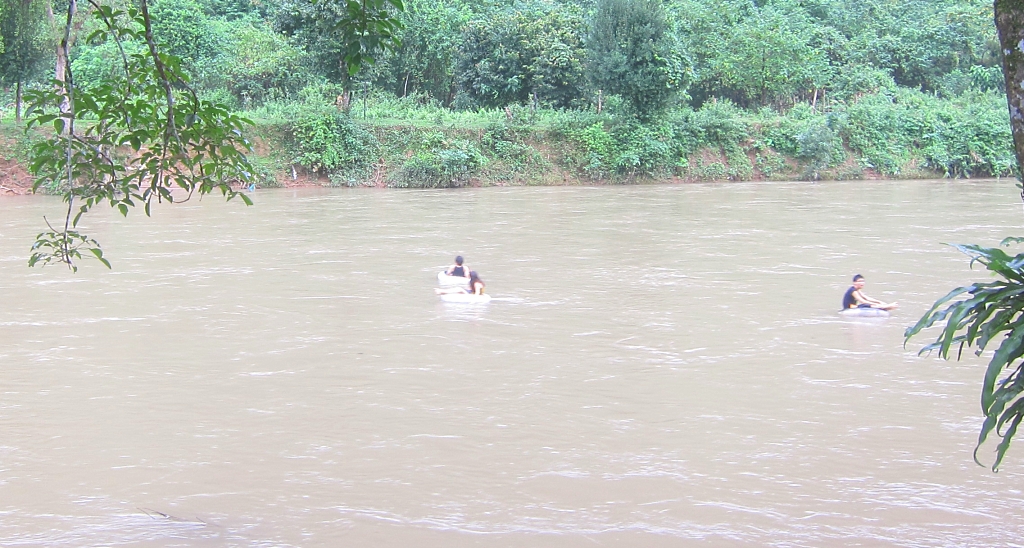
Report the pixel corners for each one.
[26,0,253,270]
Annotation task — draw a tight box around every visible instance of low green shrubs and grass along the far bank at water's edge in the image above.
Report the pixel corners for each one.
[241,88,1014,187]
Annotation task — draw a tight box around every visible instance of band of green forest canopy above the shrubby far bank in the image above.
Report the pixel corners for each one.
[0,0,1002,110]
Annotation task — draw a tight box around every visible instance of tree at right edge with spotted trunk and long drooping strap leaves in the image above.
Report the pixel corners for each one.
[906,0,1024,471]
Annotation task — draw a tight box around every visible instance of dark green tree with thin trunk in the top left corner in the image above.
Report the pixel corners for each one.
[0,0,48,123]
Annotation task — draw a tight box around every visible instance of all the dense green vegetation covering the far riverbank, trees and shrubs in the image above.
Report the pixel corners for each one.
[0,0,1014,186]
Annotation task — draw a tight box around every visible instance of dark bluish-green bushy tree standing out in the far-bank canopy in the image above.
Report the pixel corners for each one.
[587,0,687,120]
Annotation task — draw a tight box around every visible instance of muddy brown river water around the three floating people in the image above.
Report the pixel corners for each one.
[0,180,1024,547]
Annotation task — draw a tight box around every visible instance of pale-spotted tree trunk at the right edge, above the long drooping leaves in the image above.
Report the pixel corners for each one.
[994,0,1024,180]
